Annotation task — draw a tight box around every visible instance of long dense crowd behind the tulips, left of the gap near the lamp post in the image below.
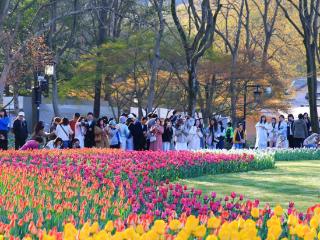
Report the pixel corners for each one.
[0,110,246,151]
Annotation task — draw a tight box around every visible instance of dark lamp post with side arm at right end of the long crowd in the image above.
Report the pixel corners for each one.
[243,83,272,129]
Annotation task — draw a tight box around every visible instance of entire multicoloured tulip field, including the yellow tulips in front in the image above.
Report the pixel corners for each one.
[0,149,320,240]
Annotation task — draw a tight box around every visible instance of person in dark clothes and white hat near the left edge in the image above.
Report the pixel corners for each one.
[12,112,28,150]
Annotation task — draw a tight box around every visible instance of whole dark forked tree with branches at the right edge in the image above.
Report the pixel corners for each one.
[277,0,320,133]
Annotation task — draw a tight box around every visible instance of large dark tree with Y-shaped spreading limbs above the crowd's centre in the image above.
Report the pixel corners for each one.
[171,0,221,116]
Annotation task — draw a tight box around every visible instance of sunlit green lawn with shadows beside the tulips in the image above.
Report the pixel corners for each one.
[179,160,320,211]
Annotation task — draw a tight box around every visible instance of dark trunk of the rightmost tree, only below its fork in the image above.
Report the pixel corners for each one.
[305,40,319,133]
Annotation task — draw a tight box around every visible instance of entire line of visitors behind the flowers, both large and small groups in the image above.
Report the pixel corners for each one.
[0,109,320,151]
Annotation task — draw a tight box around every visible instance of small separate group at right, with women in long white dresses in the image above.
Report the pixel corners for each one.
[255,113,320,149]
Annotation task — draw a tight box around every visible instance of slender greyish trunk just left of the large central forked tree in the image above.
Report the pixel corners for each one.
[147,0,164,112]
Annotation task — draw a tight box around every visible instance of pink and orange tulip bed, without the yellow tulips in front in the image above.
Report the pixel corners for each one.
[0,149,274,239]
